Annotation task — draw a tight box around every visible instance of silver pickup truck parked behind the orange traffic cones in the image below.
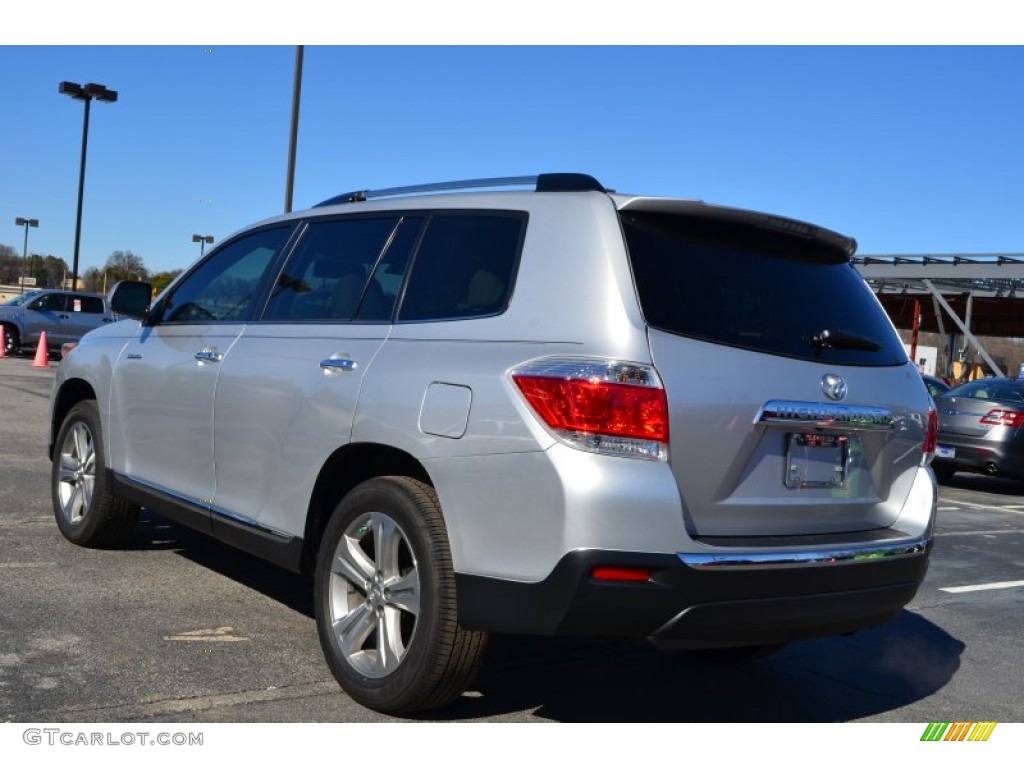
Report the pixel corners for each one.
[0,290,115,354]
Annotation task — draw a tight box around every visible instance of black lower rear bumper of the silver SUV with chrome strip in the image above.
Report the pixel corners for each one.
[457,540,931,648]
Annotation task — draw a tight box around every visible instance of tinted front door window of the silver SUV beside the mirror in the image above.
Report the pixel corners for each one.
[161,227,291,323]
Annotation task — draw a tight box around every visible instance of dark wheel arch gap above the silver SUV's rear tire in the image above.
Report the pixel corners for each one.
[300,442,434,573]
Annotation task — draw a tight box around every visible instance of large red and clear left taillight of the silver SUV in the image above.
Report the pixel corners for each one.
[511,357,669,459]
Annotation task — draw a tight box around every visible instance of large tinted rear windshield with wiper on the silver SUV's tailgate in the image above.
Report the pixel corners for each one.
[623,213,906,366]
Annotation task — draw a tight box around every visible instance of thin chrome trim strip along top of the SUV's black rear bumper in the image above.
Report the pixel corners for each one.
[677,539,932,570]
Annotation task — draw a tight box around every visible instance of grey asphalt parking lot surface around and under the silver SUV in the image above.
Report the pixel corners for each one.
[0,357,1024,723]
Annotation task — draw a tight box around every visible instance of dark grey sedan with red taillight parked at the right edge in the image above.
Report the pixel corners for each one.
[932,378,1024,480]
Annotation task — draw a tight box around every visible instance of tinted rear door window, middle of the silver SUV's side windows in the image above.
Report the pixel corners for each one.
[263,217,398,321]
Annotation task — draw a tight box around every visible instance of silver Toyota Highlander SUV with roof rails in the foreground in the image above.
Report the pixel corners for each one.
[50,174,936,713]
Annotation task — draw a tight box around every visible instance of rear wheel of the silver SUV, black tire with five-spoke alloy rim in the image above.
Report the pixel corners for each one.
[314,476,486,714]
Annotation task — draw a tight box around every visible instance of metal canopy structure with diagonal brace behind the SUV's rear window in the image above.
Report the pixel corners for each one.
[853,254,1024,376]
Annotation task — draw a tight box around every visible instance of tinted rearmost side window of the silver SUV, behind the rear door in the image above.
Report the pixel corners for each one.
[398,214,524,321]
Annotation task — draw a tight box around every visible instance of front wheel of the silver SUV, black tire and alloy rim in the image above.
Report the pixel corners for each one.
[50,400,138,548]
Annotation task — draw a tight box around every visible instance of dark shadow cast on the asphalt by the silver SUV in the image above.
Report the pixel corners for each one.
[126,514,958,723]
